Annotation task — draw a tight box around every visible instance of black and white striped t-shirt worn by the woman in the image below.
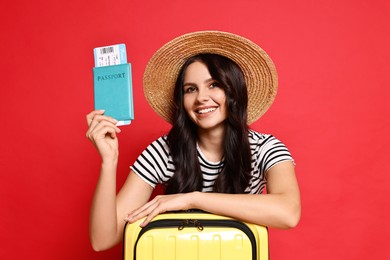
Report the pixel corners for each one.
[130,130,293,194]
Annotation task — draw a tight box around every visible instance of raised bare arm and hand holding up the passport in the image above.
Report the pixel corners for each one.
[87,111,152,251]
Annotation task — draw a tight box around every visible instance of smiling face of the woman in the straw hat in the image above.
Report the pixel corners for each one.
[183,61,227,130]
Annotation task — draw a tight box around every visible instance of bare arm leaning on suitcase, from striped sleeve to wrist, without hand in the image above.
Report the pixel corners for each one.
[193,161,301,229]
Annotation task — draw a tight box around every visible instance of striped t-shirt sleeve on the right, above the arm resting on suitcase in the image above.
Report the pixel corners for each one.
[257,135,294,173]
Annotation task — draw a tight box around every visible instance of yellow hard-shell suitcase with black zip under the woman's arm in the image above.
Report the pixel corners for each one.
[123,212,269,260]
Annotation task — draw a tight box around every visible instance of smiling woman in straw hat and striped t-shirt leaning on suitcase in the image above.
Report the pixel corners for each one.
[87,31,300,250]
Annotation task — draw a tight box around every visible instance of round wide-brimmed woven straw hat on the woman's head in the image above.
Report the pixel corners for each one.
[143,31,278,124]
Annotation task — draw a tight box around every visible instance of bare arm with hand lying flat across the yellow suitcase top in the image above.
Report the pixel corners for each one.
[127,161,301,228]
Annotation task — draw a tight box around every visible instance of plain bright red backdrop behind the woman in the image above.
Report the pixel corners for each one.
[0,0,390,259]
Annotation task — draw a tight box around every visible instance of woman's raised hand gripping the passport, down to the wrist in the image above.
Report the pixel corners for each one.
[86,110,121,161]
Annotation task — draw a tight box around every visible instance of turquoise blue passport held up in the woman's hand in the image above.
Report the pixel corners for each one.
[93,63,134,125]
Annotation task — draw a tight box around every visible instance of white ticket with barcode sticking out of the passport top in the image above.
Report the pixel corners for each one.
[93,43,127,67]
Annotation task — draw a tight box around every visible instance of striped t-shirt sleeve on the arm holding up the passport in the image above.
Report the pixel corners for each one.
[130,136,169,188]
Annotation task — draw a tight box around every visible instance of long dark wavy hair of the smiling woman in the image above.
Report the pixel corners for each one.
[165,54,251,194]
